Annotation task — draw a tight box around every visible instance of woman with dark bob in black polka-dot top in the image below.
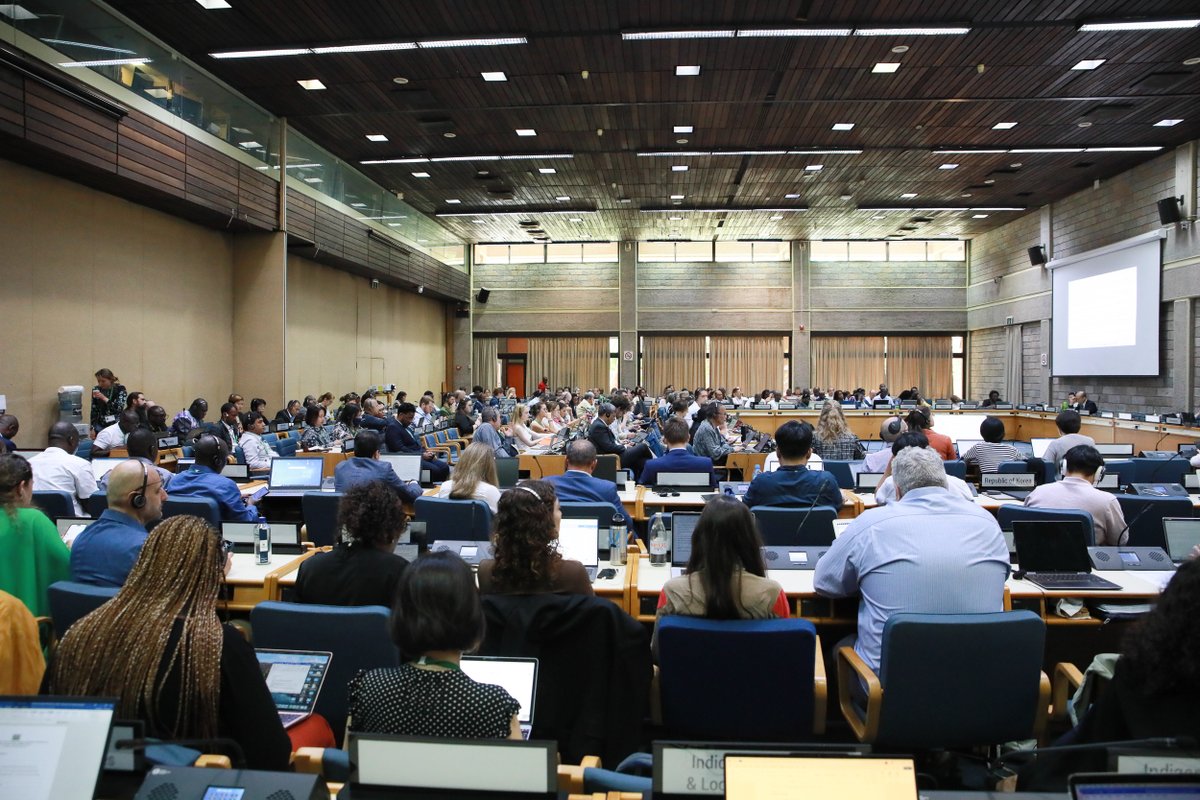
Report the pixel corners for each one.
[348,552,521,739]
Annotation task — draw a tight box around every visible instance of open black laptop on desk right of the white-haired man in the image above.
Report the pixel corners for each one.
[1013,519,1121,591]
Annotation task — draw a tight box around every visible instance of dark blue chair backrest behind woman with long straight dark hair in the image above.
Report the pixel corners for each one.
[658,615,817,741]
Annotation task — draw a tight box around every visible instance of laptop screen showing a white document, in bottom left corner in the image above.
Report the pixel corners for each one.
[0,696,116,800]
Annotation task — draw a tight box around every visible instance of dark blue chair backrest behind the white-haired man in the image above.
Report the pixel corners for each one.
[876,610,1045,748]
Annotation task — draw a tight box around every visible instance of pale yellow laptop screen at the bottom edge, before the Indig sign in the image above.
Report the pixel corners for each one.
[725,754,917,800]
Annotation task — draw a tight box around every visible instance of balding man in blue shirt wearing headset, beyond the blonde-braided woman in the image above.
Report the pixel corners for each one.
[71,460,167,587]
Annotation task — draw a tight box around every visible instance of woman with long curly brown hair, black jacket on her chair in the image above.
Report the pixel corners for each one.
[479,481,595,595]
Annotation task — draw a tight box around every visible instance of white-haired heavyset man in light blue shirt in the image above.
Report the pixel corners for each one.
[814,447,1009,674]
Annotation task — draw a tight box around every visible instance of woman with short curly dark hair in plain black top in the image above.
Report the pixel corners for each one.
[294,481,408,607]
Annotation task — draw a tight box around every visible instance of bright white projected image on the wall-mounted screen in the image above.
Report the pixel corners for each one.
[1067,266,1138,350]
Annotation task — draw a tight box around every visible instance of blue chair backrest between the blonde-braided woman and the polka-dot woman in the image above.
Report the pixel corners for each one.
[250,601,400,744]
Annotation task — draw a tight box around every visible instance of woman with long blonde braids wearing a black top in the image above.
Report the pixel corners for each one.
[43,517,292,770]
